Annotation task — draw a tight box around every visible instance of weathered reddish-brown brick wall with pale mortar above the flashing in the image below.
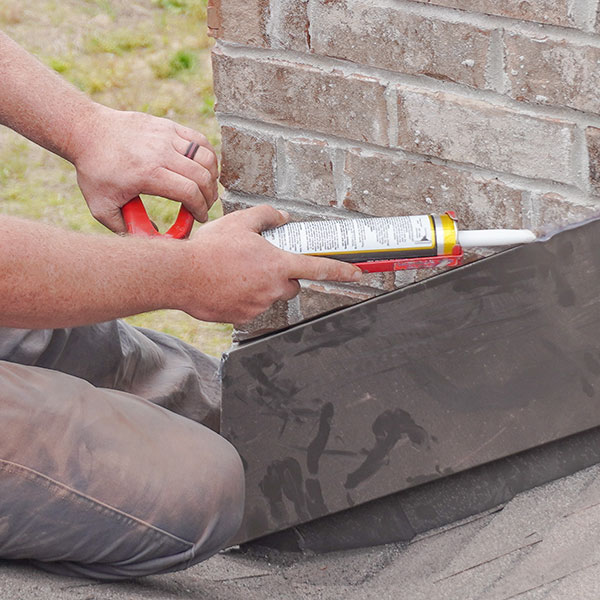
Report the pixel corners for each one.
[209,0,600,338]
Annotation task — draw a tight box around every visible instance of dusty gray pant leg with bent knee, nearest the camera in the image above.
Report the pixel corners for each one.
[0,361,243,579]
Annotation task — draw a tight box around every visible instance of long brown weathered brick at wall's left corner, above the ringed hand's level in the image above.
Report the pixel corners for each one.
[213,51,388,145]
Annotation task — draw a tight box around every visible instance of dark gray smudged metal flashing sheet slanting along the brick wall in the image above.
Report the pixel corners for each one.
[222,220,600,542]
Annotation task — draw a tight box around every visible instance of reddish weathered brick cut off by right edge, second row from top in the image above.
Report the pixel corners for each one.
[504,33,600,113]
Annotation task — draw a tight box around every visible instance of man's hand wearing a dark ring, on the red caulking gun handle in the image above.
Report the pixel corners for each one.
[68,105,219,233]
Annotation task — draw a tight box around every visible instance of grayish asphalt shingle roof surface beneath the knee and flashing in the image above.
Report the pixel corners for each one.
[0,465,600,600]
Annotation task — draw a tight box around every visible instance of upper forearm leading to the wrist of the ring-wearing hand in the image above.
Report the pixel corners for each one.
[0,32,97,162]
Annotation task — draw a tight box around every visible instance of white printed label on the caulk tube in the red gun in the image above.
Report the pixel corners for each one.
[262,215,438,262]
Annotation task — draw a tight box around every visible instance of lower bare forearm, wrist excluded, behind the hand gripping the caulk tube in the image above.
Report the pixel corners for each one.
[0,217,187,328]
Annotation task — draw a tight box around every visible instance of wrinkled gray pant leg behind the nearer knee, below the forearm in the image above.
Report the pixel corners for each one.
[0,321,221,431]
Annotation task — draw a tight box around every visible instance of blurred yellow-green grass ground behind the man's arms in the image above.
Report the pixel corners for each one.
[0,0,231,356]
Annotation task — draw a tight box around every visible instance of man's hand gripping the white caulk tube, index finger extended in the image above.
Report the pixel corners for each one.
[179,206,361,324]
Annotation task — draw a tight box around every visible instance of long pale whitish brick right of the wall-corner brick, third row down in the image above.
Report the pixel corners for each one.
[398,88,575,183]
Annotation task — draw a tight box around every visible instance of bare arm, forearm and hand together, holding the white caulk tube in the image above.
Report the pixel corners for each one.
[0,206,360,328]
